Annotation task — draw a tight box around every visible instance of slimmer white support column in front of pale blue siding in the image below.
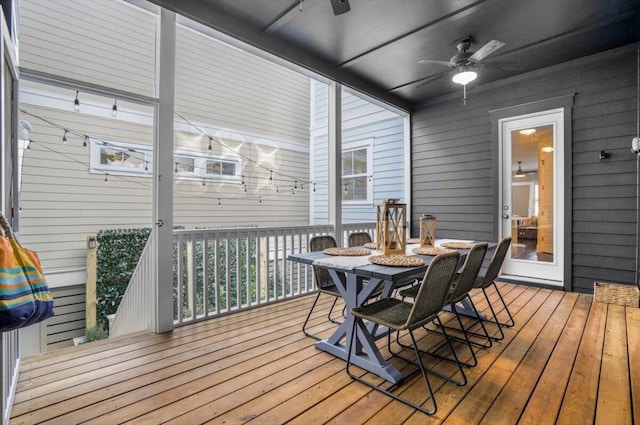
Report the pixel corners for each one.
[329,82,343,246]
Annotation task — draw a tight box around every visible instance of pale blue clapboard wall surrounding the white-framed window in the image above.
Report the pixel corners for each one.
[311,83,404,224]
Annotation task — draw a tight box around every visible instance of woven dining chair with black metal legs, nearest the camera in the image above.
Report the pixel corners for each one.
[346,251,466,415]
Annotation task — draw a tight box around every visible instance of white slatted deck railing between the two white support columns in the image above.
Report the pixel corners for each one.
[173,225,333,326]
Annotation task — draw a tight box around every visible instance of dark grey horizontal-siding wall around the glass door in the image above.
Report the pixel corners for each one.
[412,46,637,292]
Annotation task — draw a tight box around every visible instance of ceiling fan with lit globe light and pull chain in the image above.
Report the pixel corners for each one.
[416,35,506,103]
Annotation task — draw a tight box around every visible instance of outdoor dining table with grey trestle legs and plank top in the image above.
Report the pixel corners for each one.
[288,240,478,384]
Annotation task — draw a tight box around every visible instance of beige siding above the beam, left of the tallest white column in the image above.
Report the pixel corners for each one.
[19,0,157,96]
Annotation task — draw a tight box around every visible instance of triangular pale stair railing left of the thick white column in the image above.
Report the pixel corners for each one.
[109,232,156,336]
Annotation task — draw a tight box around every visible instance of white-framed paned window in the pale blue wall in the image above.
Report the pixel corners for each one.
[342,140,373,203]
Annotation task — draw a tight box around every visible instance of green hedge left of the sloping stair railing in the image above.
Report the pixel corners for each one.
[96,228,151,330]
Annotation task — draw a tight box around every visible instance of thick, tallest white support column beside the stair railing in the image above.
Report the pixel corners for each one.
[152,9,176,333]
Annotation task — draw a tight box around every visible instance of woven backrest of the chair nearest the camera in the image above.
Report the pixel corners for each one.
[406,251,460,328]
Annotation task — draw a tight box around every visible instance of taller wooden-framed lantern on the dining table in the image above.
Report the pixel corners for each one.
[376,199,407,255]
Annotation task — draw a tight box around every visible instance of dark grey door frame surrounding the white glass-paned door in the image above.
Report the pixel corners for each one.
[489,93,575,291]
